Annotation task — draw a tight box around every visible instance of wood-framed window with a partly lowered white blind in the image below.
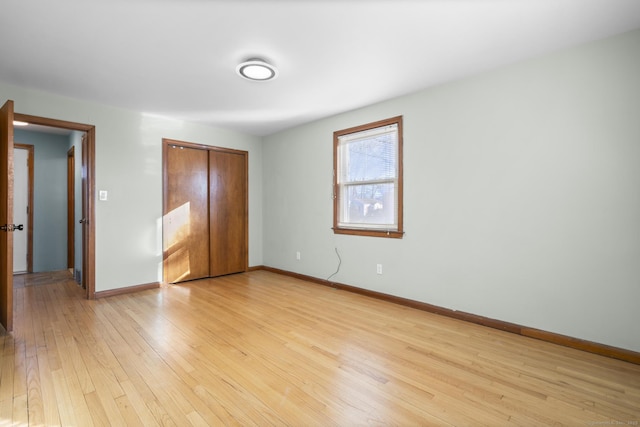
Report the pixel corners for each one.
[333,116,403,238]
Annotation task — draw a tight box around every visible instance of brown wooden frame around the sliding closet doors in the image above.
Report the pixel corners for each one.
[162,138,249,283]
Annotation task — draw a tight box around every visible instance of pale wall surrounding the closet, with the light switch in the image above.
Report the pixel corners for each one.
[0,84,262,291]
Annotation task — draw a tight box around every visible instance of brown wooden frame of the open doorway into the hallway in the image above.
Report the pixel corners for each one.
[13,112,96,299]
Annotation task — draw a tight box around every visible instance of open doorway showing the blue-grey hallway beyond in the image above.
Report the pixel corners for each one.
[13,134,72,274]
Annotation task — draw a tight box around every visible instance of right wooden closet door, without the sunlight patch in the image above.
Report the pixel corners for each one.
[209,151,248,276]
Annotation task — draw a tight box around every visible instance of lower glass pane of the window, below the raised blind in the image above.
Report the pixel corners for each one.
[341,182,396,230]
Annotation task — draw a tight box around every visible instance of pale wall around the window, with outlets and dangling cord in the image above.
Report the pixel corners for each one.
[263,31,640,351]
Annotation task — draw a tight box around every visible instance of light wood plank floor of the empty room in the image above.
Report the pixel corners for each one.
[0,271,640,426]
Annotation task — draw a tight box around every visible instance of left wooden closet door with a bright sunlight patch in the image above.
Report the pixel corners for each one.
[163,144,209,283]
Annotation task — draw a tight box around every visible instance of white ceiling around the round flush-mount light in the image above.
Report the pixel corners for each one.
[0,0,640,135]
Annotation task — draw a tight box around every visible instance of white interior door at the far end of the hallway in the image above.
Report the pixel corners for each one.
[13,148,29,273]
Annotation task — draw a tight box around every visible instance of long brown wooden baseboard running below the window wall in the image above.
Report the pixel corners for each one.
[255,265,640,365]
